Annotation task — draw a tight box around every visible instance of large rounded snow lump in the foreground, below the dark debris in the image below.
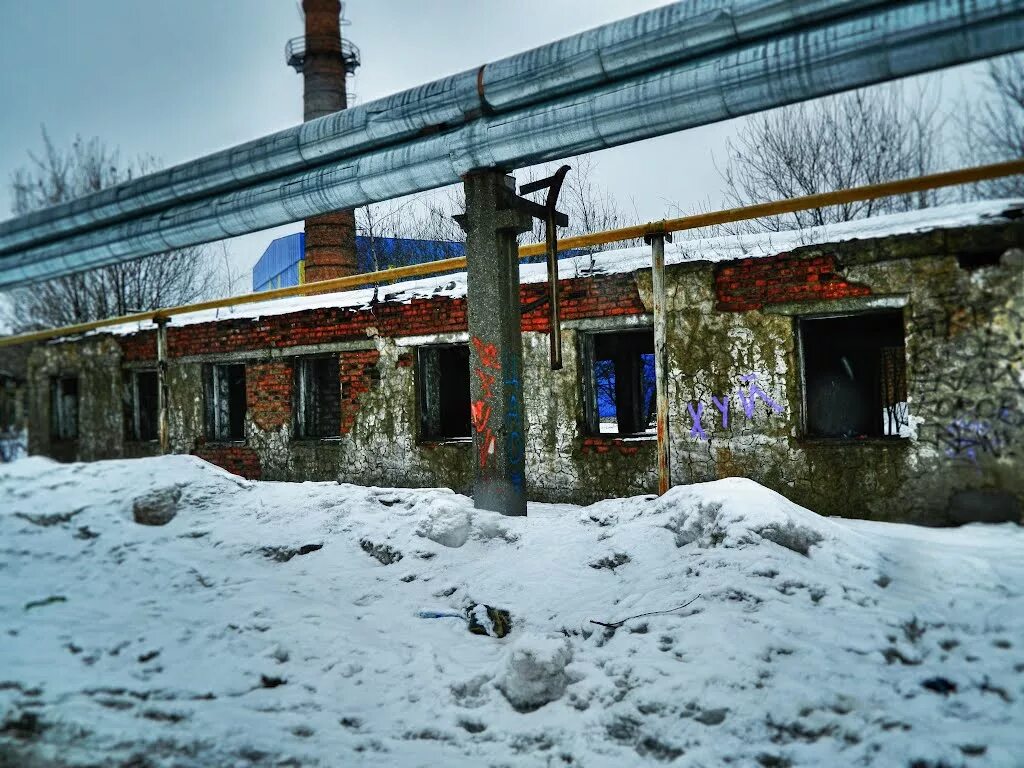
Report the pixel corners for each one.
[498,635,572,712]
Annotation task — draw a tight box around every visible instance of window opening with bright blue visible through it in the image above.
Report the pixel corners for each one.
[581,329,656,435]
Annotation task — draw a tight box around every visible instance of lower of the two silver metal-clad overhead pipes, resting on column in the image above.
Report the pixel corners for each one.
[0,0,1024,287]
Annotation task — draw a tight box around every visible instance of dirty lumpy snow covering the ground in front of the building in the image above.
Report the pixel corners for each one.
[0,457,1024,768]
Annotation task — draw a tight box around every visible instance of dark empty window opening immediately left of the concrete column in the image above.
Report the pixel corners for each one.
[416,344,472,440]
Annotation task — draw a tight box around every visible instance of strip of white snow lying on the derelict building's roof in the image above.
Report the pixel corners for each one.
[94,199,1024,336]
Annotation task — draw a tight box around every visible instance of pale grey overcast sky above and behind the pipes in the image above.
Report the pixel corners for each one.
[0,0,980,286]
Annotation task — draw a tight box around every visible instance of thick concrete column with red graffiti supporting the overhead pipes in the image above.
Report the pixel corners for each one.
[459,170,532,515]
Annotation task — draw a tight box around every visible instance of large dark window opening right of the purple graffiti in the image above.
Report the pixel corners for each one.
[799,311,909,438]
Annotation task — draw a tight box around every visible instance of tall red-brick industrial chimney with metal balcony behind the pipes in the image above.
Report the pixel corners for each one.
[285,0,359,283]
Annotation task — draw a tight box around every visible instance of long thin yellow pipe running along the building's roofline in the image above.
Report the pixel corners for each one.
[0,158,1024,348]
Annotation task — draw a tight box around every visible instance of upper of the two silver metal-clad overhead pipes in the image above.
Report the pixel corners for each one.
[0,0,905,254]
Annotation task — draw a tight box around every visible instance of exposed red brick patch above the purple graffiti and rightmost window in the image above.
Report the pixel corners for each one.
[715,253,871,312]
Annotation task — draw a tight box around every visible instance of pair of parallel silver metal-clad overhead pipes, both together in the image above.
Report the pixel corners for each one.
[0,0,1024,289]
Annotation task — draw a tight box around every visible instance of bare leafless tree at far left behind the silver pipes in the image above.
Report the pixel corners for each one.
[5,129,221,332]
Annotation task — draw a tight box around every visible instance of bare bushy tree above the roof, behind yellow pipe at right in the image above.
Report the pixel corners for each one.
[721,84,943,231]
